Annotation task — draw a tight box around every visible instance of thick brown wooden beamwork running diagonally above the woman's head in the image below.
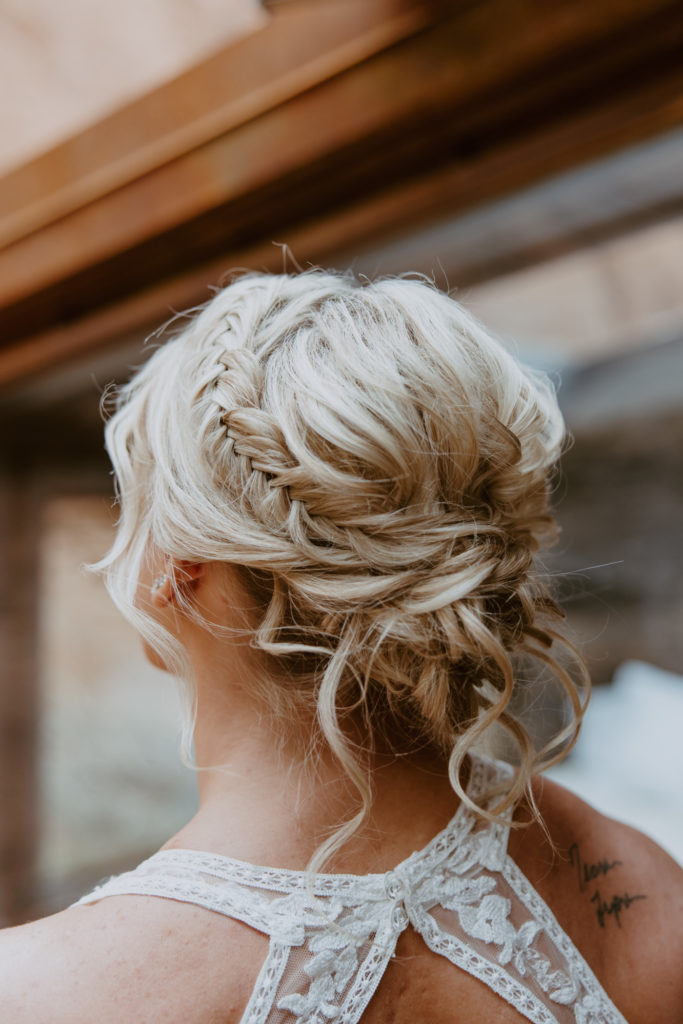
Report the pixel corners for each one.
[0,0,683,387]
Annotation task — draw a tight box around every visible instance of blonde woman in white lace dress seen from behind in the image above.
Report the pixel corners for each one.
[0,271,683,1024]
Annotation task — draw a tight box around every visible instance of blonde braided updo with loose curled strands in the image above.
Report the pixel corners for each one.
[99,270,583,849]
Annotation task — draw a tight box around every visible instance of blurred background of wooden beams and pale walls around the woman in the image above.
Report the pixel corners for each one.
[0,0,683,924]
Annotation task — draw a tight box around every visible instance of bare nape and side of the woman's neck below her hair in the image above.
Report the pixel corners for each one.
[168,573,458,872]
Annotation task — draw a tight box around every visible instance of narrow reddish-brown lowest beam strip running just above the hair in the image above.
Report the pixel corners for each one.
[0,20,683,386]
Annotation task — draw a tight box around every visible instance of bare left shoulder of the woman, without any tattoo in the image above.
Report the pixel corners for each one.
[0,884,267,1024]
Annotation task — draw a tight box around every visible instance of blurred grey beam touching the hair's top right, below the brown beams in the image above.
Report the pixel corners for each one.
[341,129,683,292]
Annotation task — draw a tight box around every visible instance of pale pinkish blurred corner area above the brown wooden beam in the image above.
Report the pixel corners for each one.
[0,0,268,174]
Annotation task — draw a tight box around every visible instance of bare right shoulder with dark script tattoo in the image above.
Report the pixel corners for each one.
[510,779,683,1024]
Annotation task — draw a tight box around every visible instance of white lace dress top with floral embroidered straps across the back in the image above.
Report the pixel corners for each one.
[74,759,626,1024]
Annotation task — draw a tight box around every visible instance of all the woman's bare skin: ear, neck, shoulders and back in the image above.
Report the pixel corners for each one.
[0,556,683,1024]
